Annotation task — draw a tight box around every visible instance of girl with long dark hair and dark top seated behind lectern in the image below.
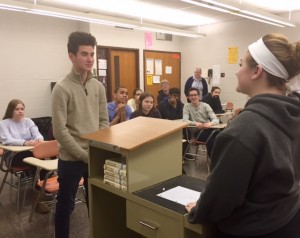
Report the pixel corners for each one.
[130,93,161,119]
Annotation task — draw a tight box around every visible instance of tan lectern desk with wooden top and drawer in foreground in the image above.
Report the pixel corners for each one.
[82,117,203,238]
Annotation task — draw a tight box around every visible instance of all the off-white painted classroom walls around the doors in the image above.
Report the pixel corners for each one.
[0,10,300,117]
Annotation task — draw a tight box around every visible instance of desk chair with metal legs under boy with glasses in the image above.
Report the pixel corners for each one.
[184,127,220,172]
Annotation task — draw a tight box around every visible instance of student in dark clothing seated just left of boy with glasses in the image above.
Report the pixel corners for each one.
[158,88,183,120]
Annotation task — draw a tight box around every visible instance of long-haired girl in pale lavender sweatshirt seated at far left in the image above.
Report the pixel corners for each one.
[0,99,44,175]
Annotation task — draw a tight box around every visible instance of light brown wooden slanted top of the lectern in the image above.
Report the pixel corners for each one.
[82,117,187,150]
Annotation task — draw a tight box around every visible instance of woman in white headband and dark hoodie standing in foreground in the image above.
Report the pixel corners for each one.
[186,34,300,238]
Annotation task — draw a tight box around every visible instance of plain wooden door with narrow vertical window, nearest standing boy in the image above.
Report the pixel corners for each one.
[108,48,139,101]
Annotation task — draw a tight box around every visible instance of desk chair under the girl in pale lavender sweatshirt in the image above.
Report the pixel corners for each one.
[0,146,33,213]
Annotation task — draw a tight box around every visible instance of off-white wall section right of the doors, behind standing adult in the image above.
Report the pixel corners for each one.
[181,12,300,107]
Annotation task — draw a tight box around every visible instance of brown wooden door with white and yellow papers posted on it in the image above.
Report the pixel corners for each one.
[144,50,181,105]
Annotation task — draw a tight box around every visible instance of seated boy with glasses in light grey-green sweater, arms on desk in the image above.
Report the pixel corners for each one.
[183,88,219,159]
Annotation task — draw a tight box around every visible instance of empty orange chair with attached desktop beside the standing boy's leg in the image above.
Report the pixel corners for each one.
[23,140,83,222]
